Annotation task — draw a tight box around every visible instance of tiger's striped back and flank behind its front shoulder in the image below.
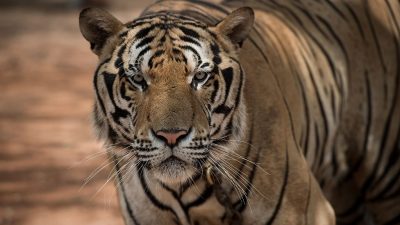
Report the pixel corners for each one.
[230,1,400,224]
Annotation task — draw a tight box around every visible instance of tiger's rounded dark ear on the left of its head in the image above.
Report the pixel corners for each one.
[79,8,123,55]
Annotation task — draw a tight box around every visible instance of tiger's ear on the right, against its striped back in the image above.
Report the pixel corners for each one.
[216,7,254,46]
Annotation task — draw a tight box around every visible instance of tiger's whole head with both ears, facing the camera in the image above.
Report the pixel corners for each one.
[79,8,254,183]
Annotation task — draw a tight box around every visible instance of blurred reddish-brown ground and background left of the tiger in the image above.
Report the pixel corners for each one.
[0,0,153,225]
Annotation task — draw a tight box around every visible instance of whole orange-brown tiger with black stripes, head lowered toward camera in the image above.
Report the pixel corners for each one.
[79,0,400,225]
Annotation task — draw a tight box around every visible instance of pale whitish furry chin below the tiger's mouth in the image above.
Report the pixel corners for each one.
[152,157,196,184]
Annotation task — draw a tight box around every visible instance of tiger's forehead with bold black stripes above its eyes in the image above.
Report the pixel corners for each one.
[122,13,217,73]
